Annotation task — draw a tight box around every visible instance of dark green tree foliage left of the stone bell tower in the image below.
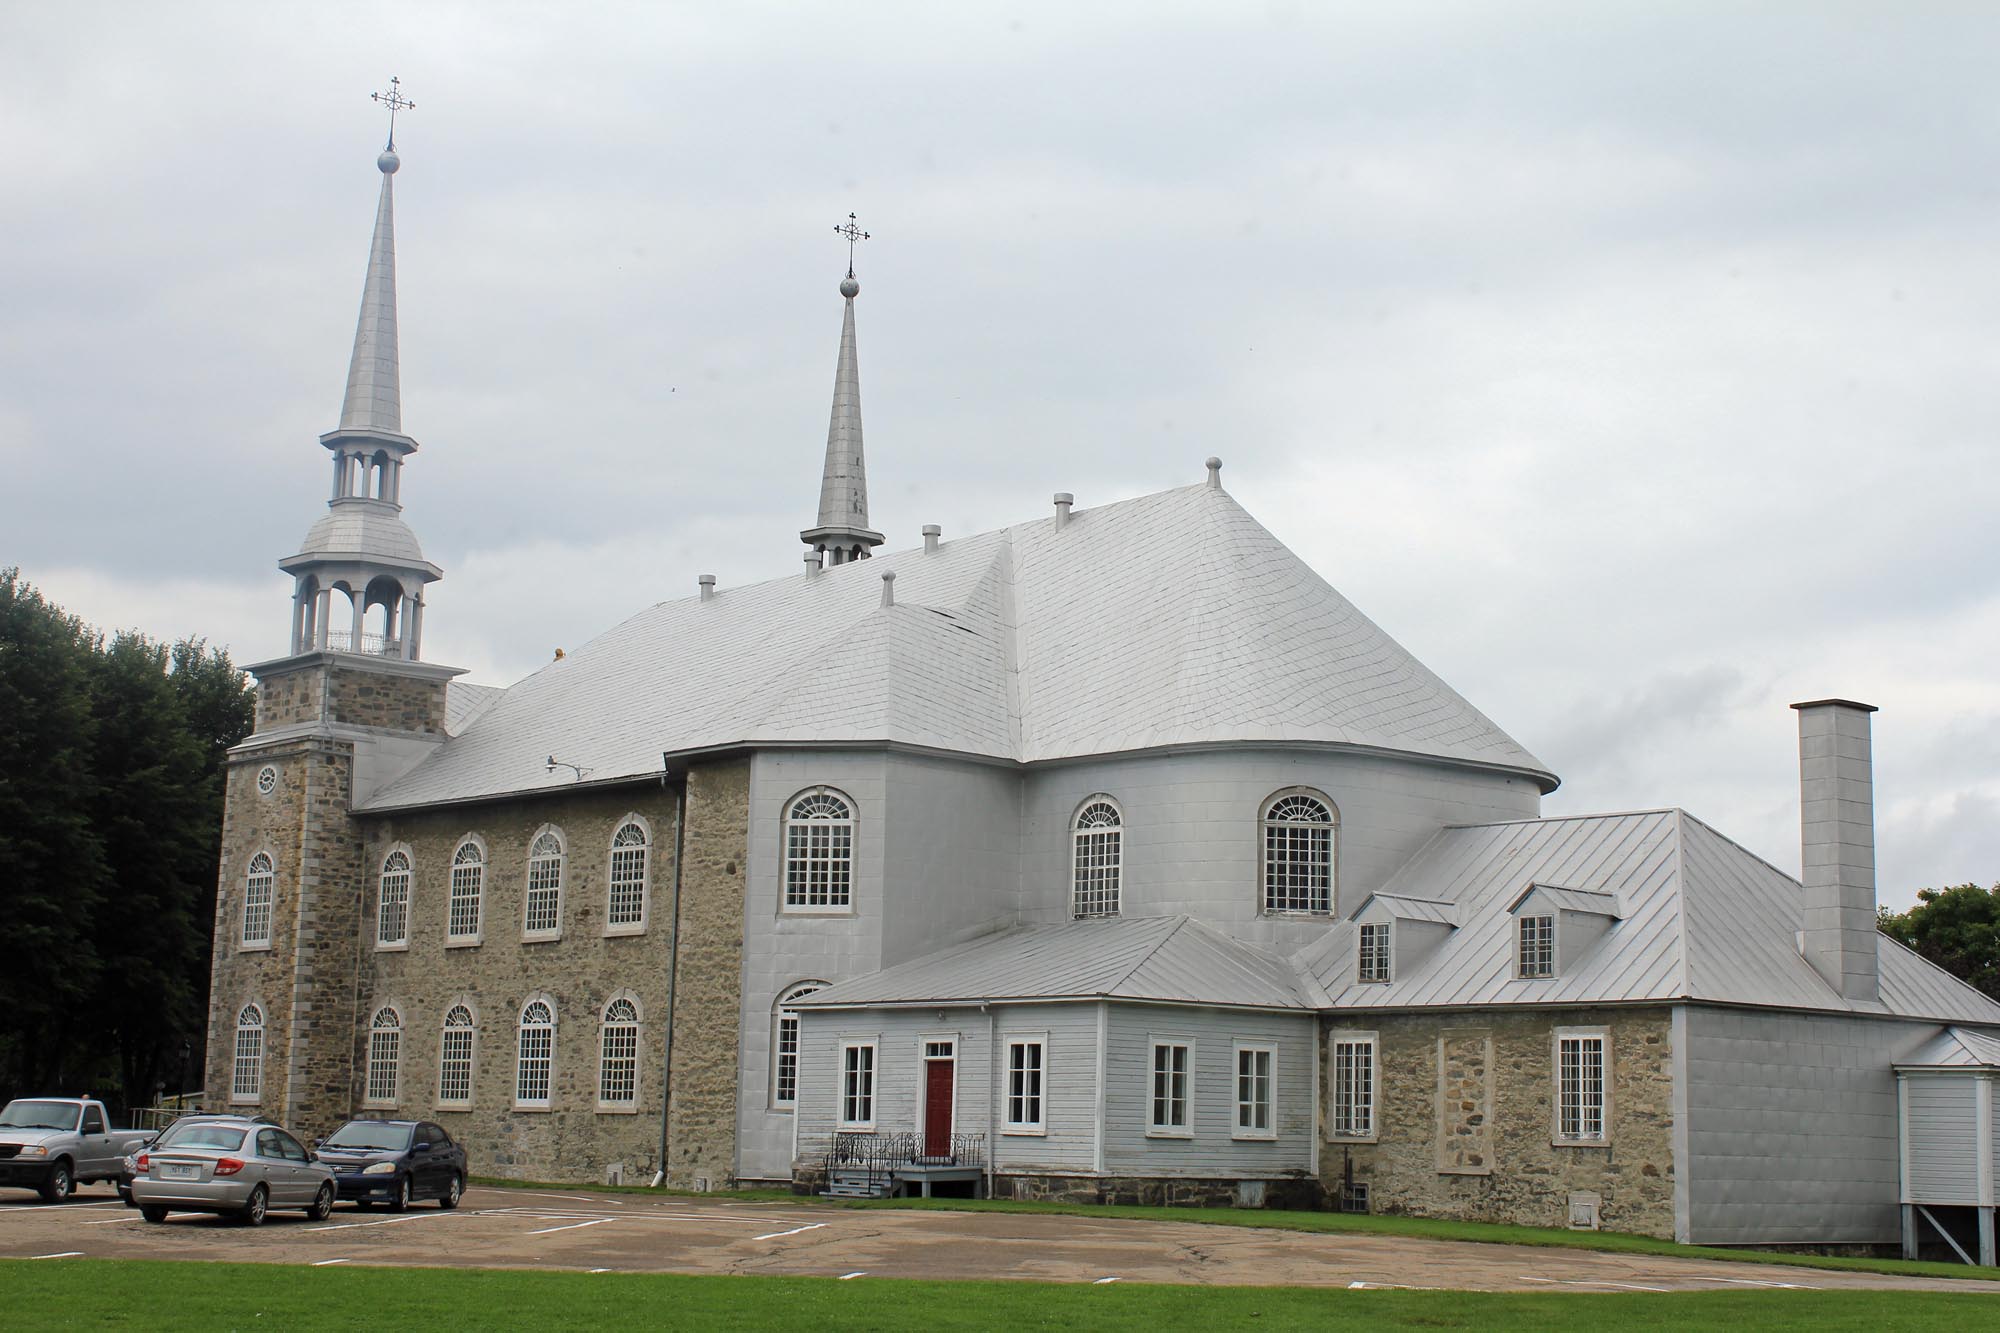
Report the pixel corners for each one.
[0,568,254,1105]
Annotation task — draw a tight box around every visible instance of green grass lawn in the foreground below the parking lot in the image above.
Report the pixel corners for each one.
[0,1259,1994,1333]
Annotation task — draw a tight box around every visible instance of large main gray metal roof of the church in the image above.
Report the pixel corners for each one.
[370,486,1556,809]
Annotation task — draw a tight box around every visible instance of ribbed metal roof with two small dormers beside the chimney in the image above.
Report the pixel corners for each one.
[1296,811,2000,1023]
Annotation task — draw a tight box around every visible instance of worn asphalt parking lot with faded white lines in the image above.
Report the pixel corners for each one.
[0,1187,2000,1293]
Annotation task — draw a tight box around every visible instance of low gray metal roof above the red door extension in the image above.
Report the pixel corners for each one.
[798,917,1312,1009]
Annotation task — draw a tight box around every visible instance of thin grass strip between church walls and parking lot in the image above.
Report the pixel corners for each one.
[464,1177,2000,1281]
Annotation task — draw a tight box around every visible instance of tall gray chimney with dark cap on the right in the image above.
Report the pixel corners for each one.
[1792,699,1882,1001]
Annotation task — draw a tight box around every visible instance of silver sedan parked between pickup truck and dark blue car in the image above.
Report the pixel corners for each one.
[132,1117,334,1227]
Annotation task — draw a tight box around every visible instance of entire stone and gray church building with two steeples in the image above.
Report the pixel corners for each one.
[208,127,2000,1257]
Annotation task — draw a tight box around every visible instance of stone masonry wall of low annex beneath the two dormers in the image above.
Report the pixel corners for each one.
[1320,1009,1674,1239]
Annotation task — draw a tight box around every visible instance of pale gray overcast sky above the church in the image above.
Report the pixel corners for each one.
[0,0,2000,905]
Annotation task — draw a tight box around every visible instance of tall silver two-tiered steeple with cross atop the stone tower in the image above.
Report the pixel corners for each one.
[278,80,444,662]
